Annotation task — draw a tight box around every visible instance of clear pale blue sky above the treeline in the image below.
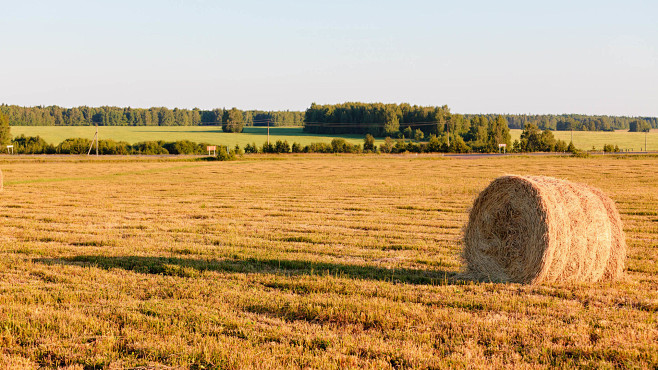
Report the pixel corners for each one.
[0,0,658,116]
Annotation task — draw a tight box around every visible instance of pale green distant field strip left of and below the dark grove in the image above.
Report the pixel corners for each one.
[11,126,363,147]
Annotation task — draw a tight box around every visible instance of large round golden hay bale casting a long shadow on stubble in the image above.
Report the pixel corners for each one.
[462,175,626,284]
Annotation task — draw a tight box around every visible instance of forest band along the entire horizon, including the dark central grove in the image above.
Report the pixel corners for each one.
[0,103,658,136]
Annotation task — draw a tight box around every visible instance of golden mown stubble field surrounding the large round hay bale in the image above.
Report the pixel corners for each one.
[0,155,658,369]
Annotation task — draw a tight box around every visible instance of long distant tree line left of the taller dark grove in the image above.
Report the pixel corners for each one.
[0,104,304,126]
